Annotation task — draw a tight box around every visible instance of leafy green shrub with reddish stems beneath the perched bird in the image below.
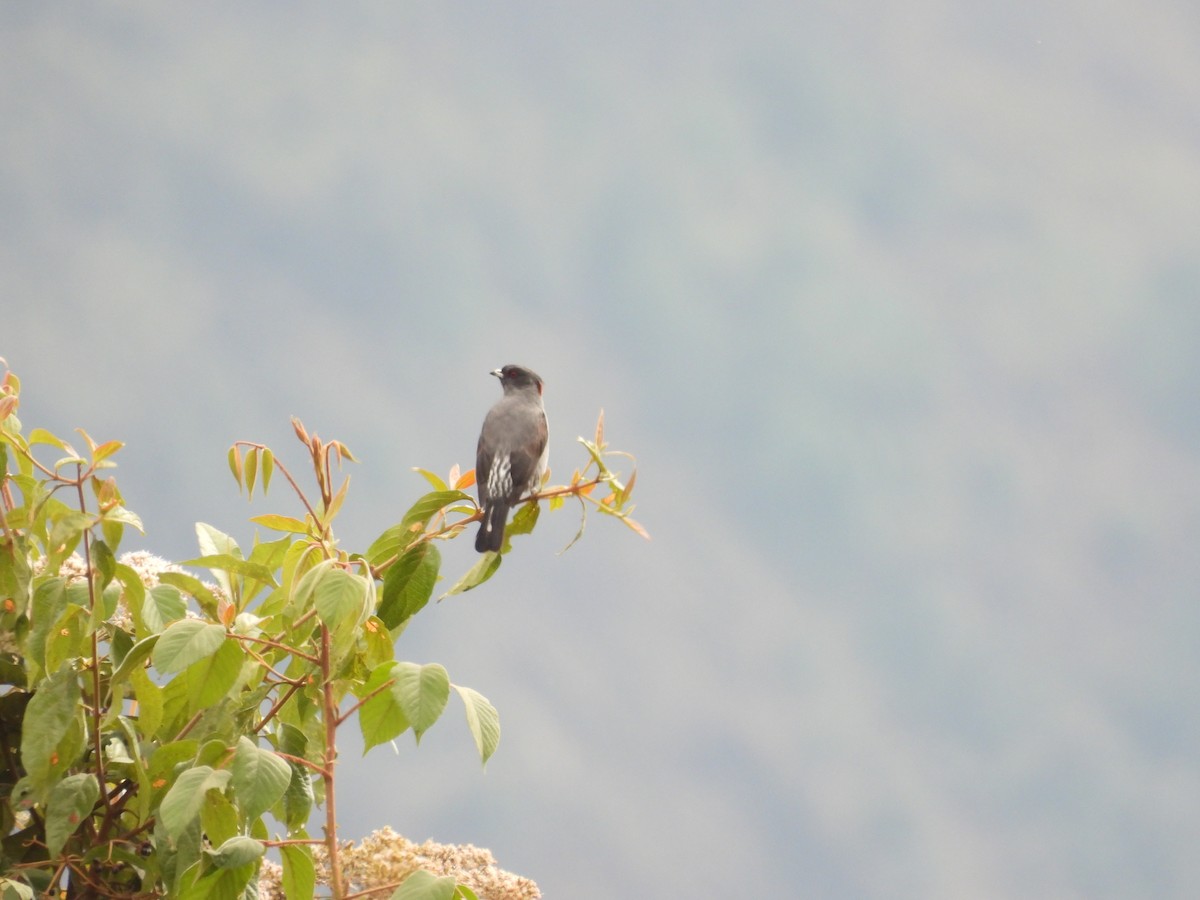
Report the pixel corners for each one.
[0,372,644,900]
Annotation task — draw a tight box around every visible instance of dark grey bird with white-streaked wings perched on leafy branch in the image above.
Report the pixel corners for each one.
[475,365,550,553]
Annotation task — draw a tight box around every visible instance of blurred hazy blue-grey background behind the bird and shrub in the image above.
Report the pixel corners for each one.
[0,0,1200,900]
